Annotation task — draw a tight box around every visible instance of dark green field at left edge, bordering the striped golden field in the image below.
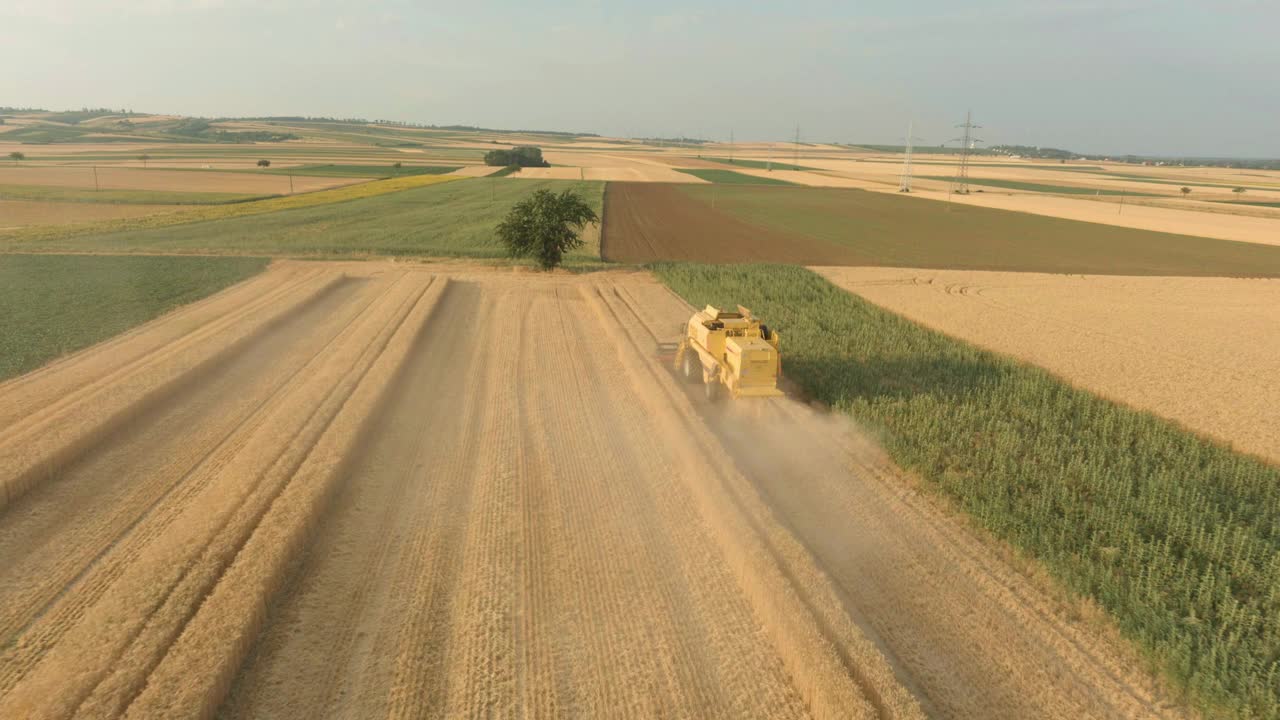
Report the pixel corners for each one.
[0,255,266,380]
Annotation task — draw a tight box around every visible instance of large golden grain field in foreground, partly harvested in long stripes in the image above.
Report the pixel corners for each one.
[0,263,1167,717]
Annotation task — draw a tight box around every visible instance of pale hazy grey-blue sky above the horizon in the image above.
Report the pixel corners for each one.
[0,0,1280,158]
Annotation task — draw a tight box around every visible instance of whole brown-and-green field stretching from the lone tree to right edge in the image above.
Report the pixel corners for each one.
[603,183,1280,277]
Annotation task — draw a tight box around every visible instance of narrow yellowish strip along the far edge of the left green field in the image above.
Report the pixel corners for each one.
[0,176,458,252]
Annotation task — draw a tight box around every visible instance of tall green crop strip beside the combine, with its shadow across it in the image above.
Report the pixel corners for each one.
[654,264,1280,719]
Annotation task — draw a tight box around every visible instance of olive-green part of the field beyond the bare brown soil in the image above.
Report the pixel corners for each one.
[670,184,1280,277]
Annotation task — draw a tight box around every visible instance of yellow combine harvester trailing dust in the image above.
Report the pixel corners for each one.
[675,305,782,401]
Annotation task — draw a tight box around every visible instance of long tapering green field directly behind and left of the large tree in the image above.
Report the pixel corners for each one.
[6,178,604,261]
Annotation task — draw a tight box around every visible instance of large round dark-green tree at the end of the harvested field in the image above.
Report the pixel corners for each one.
[498,188,599,270]
